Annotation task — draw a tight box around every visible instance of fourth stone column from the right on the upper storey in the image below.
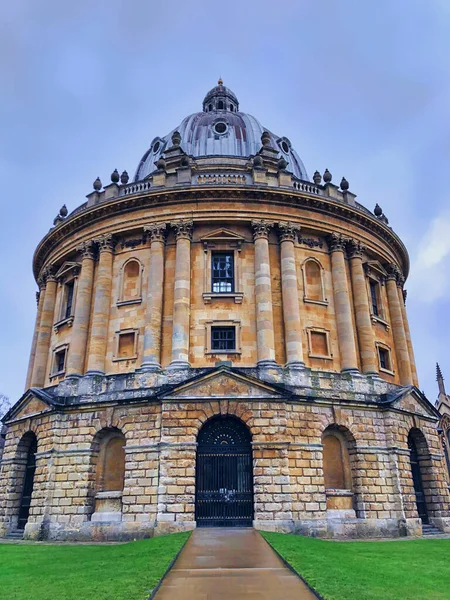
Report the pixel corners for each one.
[328,233,358,373]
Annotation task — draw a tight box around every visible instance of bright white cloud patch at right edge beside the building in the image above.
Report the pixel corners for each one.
[408,208,450,304]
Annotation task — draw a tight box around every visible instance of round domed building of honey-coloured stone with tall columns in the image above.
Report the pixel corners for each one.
[0,81,450,540]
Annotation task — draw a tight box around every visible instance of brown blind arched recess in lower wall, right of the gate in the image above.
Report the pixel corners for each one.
[323,430,352,490]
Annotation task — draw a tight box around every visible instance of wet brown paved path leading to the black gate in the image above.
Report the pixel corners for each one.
[155,529,316,600]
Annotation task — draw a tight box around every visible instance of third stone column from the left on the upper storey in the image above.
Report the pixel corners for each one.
[66,240,94,377]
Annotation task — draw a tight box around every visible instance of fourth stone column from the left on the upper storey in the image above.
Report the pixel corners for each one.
[87,234,114,375]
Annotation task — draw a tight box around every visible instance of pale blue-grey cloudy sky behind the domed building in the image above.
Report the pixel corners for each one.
[0,0,450,402]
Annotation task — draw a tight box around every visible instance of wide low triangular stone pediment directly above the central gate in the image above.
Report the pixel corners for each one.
[160,368,291,400]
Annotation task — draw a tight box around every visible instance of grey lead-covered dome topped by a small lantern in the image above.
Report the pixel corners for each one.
[134,79,309,181]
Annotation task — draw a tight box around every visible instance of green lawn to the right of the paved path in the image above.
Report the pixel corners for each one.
[263,533,450,600]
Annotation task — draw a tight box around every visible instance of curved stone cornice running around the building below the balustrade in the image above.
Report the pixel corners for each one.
[33,185,409,278]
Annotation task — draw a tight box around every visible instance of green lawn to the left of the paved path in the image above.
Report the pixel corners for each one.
[0,533,189,600]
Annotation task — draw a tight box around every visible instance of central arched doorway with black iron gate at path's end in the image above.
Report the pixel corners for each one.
[195,415,253,527]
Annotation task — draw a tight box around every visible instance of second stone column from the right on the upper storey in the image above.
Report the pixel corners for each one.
[386,264,412,385]
